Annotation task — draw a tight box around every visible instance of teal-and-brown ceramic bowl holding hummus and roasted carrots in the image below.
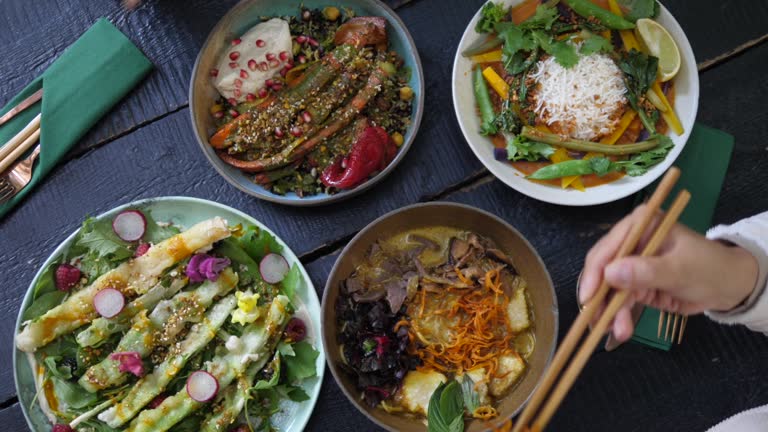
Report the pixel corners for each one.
[189,0,424,206]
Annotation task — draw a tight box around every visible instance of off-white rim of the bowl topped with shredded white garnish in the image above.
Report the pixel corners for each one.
[451,0,701,207]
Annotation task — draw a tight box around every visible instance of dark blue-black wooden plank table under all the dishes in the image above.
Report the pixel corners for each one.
[0,0,768,432]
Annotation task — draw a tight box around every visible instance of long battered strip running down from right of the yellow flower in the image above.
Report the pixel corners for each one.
[124,295,290,432]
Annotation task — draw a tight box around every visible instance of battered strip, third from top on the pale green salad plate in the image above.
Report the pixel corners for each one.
[78,267,238,393]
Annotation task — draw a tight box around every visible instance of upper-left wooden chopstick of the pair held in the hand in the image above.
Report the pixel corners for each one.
[512,167,680,432]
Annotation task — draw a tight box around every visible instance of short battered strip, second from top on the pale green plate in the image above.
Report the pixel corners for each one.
[76,277,189,347]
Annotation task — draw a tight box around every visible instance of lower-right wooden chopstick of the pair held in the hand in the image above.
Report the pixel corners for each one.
[532,190,691,431]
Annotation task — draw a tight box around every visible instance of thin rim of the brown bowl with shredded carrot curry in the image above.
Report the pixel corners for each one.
[320,201,560,432]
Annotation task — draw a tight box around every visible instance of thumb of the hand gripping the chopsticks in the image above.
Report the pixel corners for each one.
[604,256,670,291]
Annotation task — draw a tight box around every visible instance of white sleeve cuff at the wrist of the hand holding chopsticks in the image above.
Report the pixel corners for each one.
[706,212,768,334]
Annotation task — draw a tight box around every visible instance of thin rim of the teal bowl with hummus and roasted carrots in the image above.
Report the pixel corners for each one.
[187,0,425,207]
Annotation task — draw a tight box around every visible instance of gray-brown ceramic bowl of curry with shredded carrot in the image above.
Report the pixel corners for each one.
[322,202,558,432]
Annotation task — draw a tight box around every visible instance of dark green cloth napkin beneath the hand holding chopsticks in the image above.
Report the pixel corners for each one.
[632,123,733,351]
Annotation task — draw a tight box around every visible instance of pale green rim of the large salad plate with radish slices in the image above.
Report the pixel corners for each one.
[12,195,326,431]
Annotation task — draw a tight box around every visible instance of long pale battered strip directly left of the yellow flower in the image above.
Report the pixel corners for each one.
[99,295,237,428]
